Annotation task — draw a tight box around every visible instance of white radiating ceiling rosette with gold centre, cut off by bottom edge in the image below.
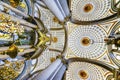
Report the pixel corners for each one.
[66,62,106,80]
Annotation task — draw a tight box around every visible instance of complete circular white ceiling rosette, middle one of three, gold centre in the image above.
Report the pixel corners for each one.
[68,25,107,59]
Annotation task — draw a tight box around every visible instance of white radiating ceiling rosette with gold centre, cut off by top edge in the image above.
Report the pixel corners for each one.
[71,0,110,21]
